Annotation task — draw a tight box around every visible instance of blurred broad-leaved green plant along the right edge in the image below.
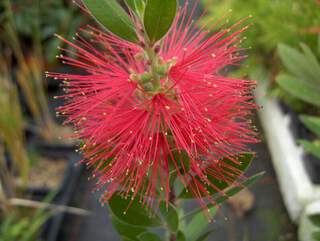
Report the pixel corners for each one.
[276,44,320,162]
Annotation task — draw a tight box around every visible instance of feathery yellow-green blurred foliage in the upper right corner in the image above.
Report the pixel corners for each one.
[202,0,320,111]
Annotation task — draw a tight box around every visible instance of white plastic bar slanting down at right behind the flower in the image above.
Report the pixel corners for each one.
[256,82,320,223]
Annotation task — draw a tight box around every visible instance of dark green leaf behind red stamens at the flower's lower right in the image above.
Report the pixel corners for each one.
[179,153,253,199]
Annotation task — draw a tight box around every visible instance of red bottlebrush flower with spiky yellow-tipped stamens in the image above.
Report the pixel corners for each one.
[48,1,256,210]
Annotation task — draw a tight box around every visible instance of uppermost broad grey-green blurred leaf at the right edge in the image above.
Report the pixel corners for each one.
[278,44,320,84]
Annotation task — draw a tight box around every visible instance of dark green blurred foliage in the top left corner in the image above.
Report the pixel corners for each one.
[0,0,84,66]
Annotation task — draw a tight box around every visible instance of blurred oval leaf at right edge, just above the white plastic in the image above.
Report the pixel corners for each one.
[277,74,320,106]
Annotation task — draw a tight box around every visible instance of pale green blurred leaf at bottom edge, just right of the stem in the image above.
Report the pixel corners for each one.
[184,207,217,241]
